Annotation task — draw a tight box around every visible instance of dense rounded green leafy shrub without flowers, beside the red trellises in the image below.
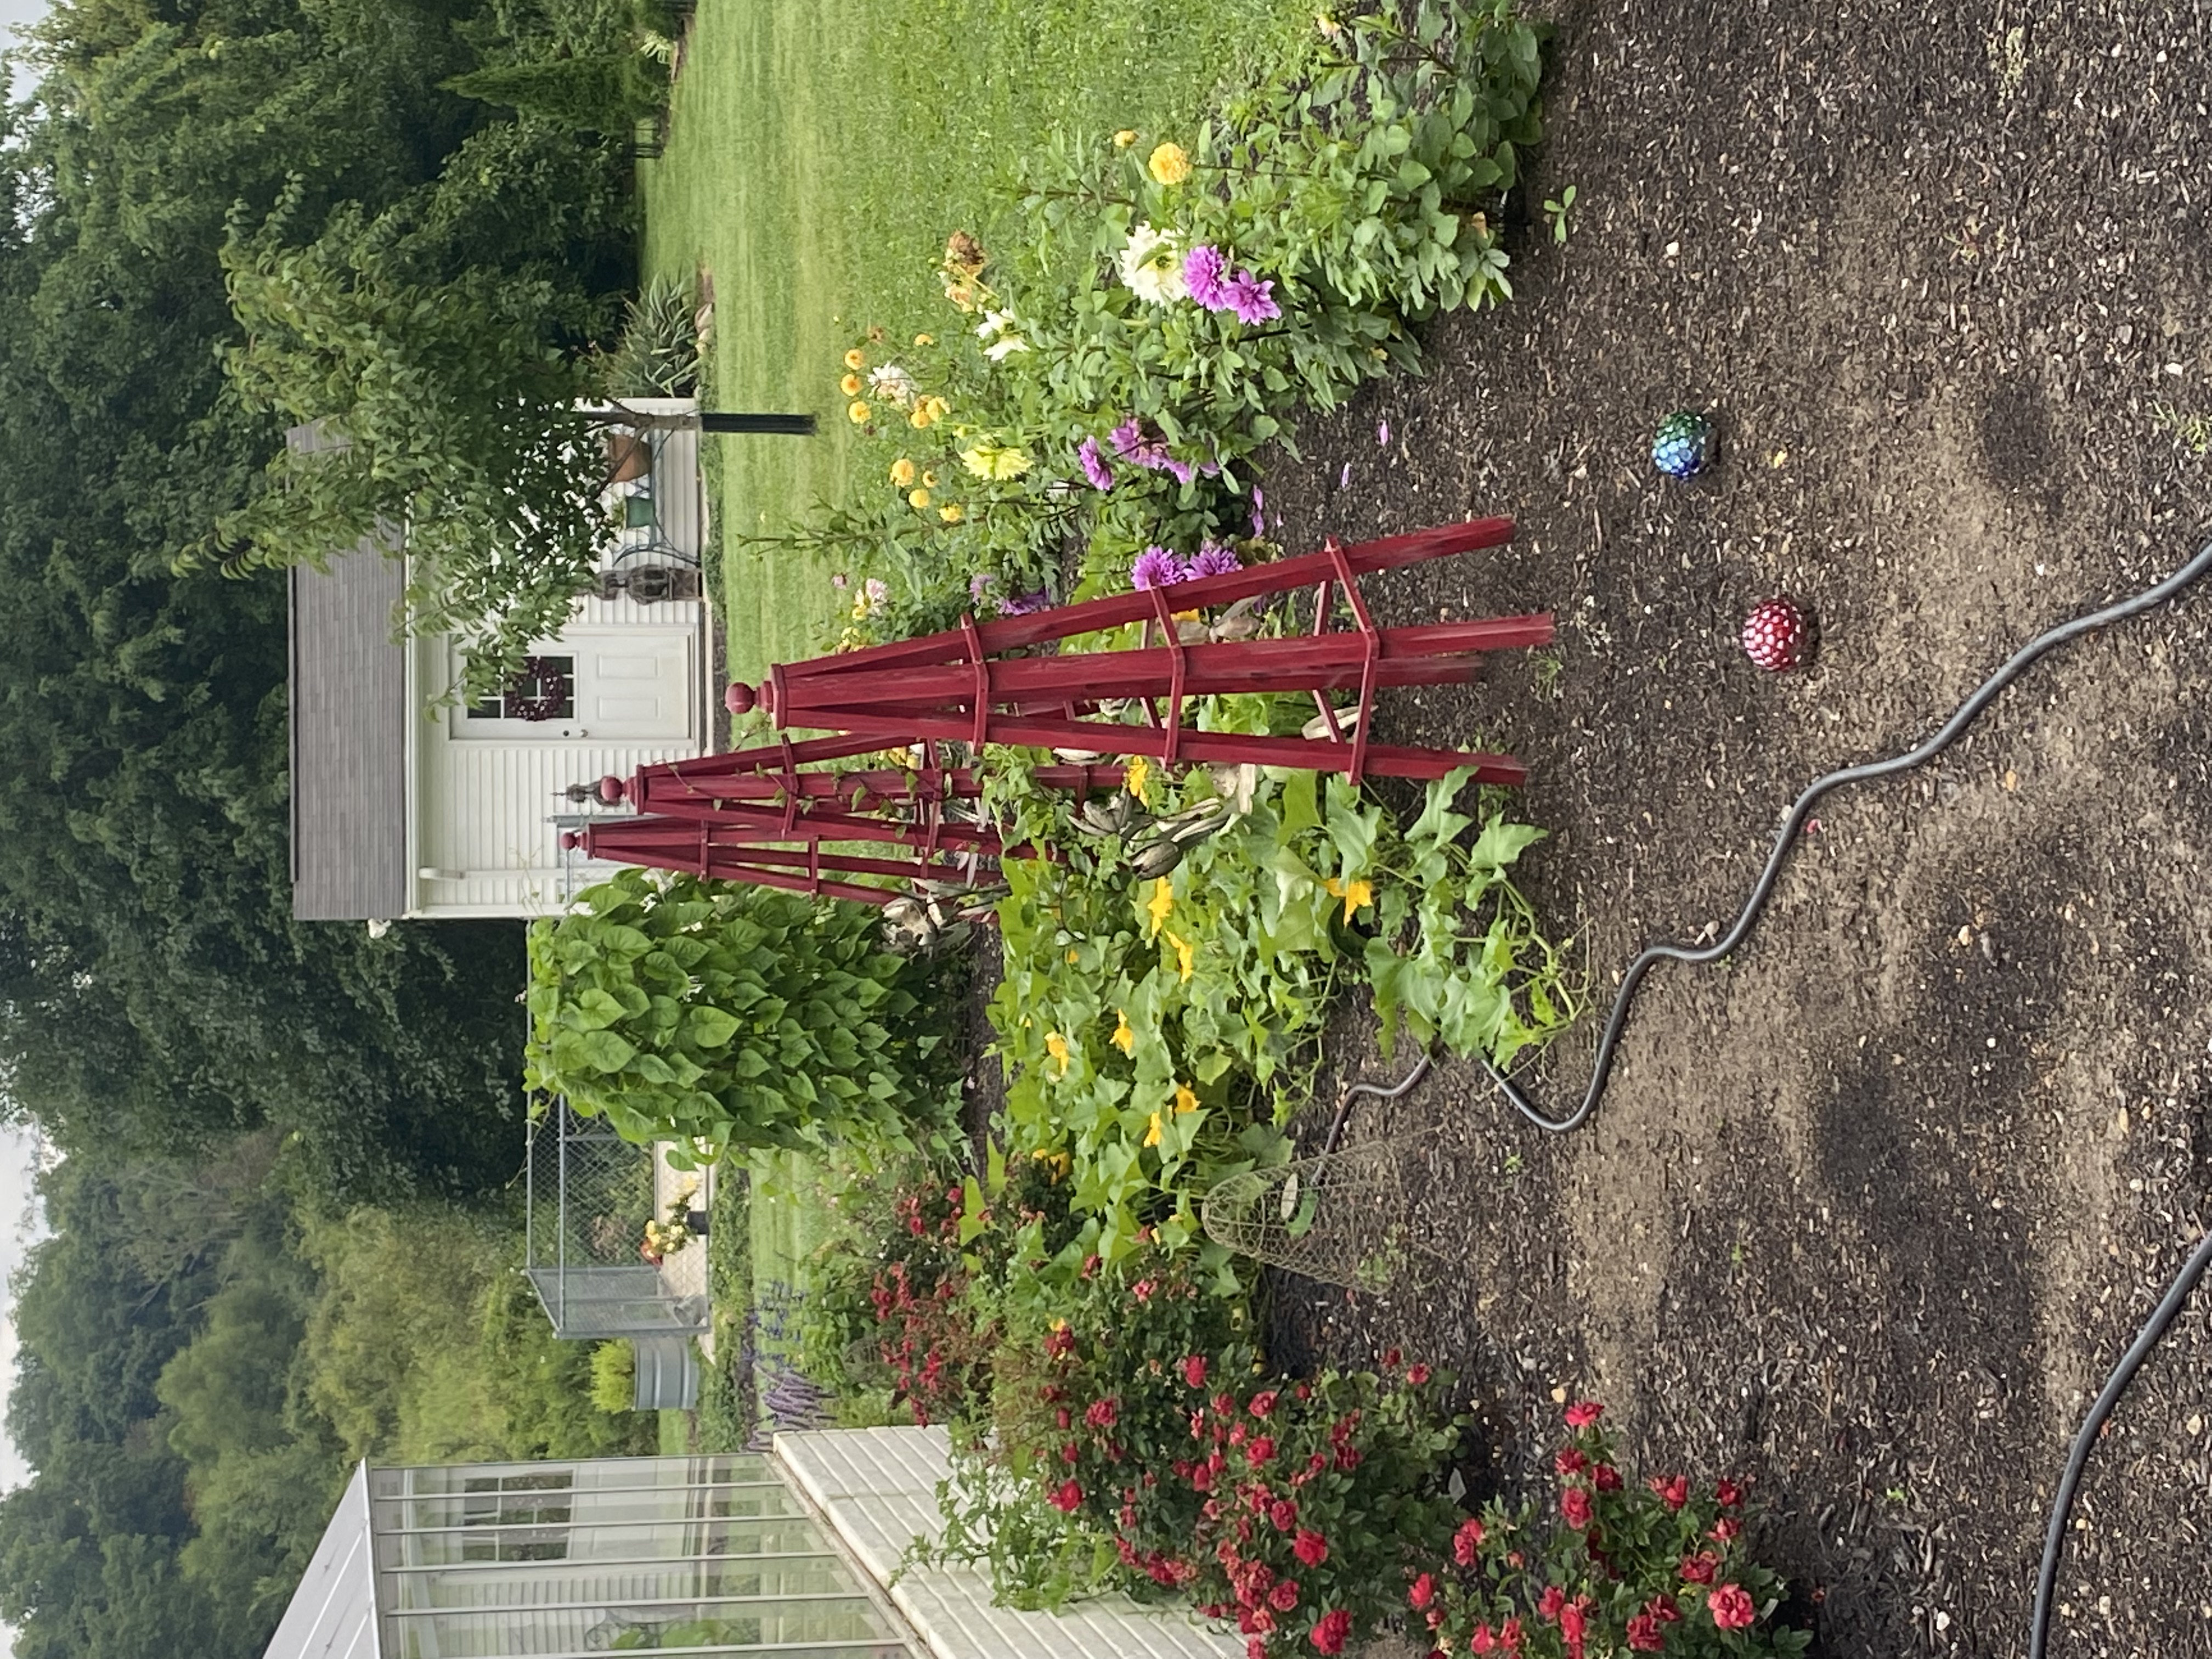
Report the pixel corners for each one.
[524,870,943,1164]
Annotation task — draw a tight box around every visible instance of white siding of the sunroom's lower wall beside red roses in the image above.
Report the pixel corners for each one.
[774,1429,1245,1659]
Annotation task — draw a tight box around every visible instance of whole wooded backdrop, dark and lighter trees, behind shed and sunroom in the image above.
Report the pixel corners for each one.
[0,0,654,1659]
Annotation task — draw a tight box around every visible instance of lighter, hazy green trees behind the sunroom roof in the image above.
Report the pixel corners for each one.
[0,1159,654,1659]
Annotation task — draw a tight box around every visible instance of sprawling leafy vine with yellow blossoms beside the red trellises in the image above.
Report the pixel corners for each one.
[991,763,1573,1288]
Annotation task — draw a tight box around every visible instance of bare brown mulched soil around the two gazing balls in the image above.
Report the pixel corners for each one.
[1267,0,2212,1659]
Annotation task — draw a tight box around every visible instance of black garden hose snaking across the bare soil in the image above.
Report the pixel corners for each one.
[1329,542,2212,1659]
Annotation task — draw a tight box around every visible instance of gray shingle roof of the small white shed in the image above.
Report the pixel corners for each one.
[292,542,411,922]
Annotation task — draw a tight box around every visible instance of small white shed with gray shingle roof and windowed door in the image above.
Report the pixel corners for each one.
[290,398,712,920]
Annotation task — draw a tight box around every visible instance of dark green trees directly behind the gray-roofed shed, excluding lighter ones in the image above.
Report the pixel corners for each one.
[0,0,659,1194]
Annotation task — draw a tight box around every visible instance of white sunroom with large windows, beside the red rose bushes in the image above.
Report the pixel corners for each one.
[268,1429,1243,1659]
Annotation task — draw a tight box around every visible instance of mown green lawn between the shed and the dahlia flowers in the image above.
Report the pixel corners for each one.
[639,0,1314,679]
